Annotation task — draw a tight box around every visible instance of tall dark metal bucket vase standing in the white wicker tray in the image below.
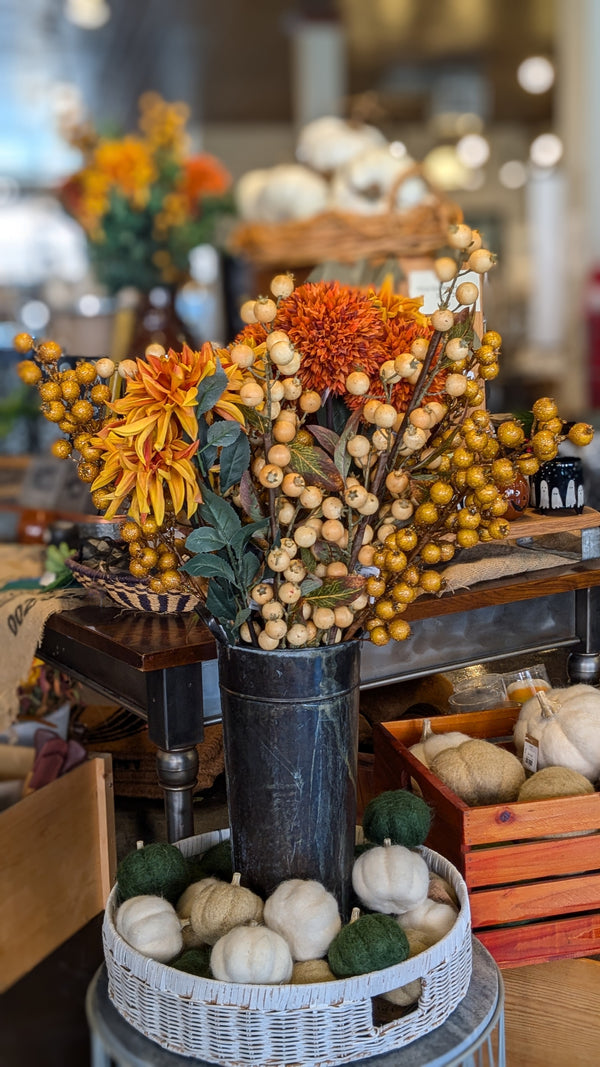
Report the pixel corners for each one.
[218,641,360,918]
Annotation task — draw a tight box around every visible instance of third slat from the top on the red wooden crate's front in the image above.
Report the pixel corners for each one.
[470,874,600,927]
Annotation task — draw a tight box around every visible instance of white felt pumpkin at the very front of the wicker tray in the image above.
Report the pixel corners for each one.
[210,923,294,985]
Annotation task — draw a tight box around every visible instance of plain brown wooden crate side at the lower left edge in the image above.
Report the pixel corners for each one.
[0,755,115,992]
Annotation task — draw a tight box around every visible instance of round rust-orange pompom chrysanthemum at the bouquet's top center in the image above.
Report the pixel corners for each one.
[274,282,385,399]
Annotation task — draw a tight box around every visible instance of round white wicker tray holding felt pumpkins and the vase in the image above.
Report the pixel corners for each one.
[102,830,472,1067]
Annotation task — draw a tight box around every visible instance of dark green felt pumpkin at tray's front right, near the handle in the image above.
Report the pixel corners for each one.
[327,912,410,978]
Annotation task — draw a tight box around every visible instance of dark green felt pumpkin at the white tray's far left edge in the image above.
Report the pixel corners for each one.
[116,842,189,904]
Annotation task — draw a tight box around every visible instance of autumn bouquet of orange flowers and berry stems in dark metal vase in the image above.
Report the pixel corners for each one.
[15,223,593,650]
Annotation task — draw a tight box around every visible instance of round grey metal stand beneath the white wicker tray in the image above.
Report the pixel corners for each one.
[85,939,506,1067]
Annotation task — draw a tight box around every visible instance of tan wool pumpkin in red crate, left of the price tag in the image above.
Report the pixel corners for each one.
[431,737,525,807]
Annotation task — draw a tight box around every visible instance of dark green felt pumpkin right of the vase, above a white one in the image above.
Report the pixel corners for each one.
[363,790,432,848]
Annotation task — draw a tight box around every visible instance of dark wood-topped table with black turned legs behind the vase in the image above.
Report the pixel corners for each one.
[38,508,600,841]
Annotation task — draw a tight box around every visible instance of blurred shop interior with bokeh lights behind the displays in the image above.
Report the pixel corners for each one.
[0,0,600,524]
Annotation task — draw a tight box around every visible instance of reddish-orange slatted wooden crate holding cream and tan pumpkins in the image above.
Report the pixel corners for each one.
[374,708,600,967]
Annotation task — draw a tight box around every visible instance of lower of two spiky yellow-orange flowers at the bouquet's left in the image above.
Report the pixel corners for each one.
[92,423,202,526]
